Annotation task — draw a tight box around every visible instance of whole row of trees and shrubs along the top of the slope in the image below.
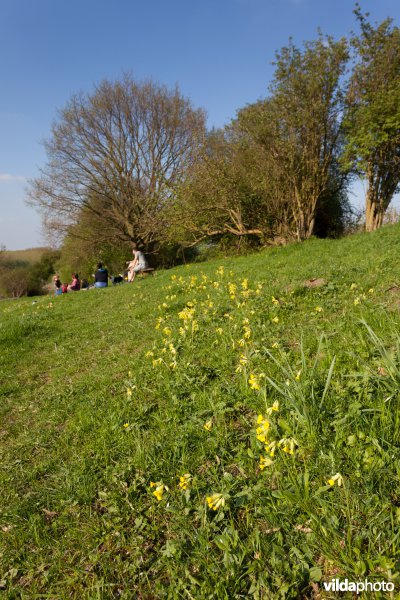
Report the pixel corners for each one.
[19,6,400,284]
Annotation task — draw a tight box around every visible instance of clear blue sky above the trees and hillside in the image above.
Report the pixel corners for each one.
[0,0,400,249]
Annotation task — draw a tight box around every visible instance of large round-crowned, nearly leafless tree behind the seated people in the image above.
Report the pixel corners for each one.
[28,75,205,248]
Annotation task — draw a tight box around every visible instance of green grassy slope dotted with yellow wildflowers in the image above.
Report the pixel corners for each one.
[0,226,400,599]
